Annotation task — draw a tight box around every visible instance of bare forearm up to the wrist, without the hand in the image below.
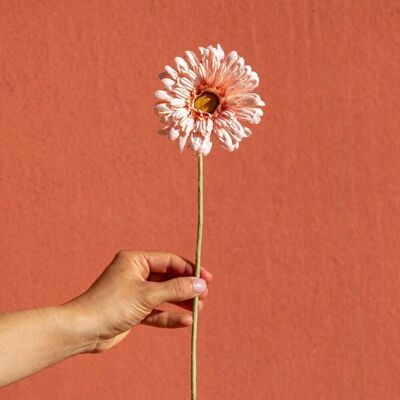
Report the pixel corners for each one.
[0,306,93,387]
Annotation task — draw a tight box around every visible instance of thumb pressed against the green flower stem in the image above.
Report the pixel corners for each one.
[148,276,207,307]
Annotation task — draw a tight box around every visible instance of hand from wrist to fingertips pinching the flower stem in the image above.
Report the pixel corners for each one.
[63,250,212,353]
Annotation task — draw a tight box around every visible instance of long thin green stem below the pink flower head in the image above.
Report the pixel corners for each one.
[192,154,203,400]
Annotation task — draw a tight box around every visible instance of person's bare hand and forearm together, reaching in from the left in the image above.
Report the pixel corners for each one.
[0,250,212,387]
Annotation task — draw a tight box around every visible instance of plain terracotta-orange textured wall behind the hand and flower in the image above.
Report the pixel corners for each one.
[0,0,400,400]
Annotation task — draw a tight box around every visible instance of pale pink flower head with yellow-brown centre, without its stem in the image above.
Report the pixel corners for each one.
[154,44,265,155]
